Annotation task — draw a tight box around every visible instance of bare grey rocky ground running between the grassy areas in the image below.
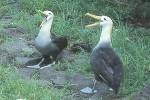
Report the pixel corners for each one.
[0,1,150,100]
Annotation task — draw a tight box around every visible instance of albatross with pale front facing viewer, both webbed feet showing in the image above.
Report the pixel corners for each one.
[26,11,67,69]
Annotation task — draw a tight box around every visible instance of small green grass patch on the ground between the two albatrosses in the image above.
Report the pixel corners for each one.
[54,52,91,74]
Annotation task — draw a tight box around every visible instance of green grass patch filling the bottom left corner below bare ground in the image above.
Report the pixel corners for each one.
[0,65,67,100]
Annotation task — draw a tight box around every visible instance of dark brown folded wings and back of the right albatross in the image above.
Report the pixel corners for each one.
[91,47,123,93]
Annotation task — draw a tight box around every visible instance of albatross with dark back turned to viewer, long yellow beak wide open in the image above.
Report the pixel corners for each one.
[83,13,123,94]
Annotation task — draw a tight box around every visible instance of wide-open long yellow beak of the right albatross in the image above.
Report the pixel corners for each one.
[85,13,101,28]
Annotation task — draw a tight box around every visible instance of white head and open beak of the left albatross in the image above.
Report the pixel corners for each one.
[39,10,54,27]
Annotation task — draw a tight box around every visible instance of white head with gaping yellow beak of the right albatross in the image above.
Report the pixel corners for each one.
[85,13,113,27]
